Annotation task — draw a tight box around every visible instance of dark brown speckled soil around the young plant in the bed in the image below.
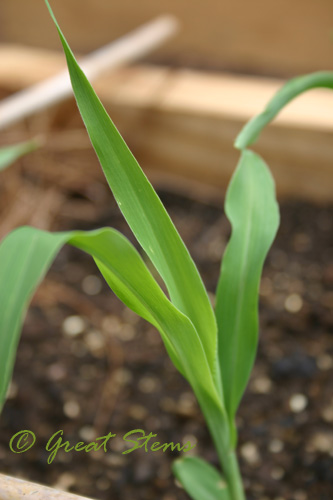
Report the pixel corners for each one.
[0,185,333,500]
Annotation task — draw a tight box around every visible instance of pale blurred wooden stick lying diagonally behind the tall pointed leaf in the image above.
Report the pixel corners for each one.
[0,16,178,130]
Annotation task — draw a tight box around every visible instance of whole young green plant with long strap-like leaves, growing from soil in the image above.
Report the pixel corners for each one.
[0,0,333,500]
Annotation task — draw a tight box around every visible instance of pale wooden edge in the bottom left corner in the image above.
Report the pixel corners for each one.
[0,474,94,500]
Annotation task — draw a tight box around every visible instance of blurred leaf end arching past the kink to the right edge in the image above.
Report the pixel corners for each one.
[235,71,333,149]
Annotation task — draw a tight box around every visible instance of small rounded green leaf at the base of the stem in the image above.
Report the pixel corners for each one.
[172,457,230,500]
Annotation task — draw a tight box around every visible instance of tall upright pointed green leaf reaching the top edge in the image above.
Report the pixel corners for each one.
[45,0,217,371]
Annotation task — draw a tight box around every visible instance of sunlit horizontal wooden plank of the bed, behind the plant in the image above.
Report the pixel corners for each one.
[0,44,333,202]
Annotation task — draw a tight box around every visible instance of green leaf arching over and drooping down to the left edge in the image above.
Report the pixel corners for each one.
[0,227,222,436]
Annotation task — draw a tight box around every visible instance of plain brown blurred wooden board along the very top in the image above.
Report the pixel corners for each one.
[0,0,333,76]
